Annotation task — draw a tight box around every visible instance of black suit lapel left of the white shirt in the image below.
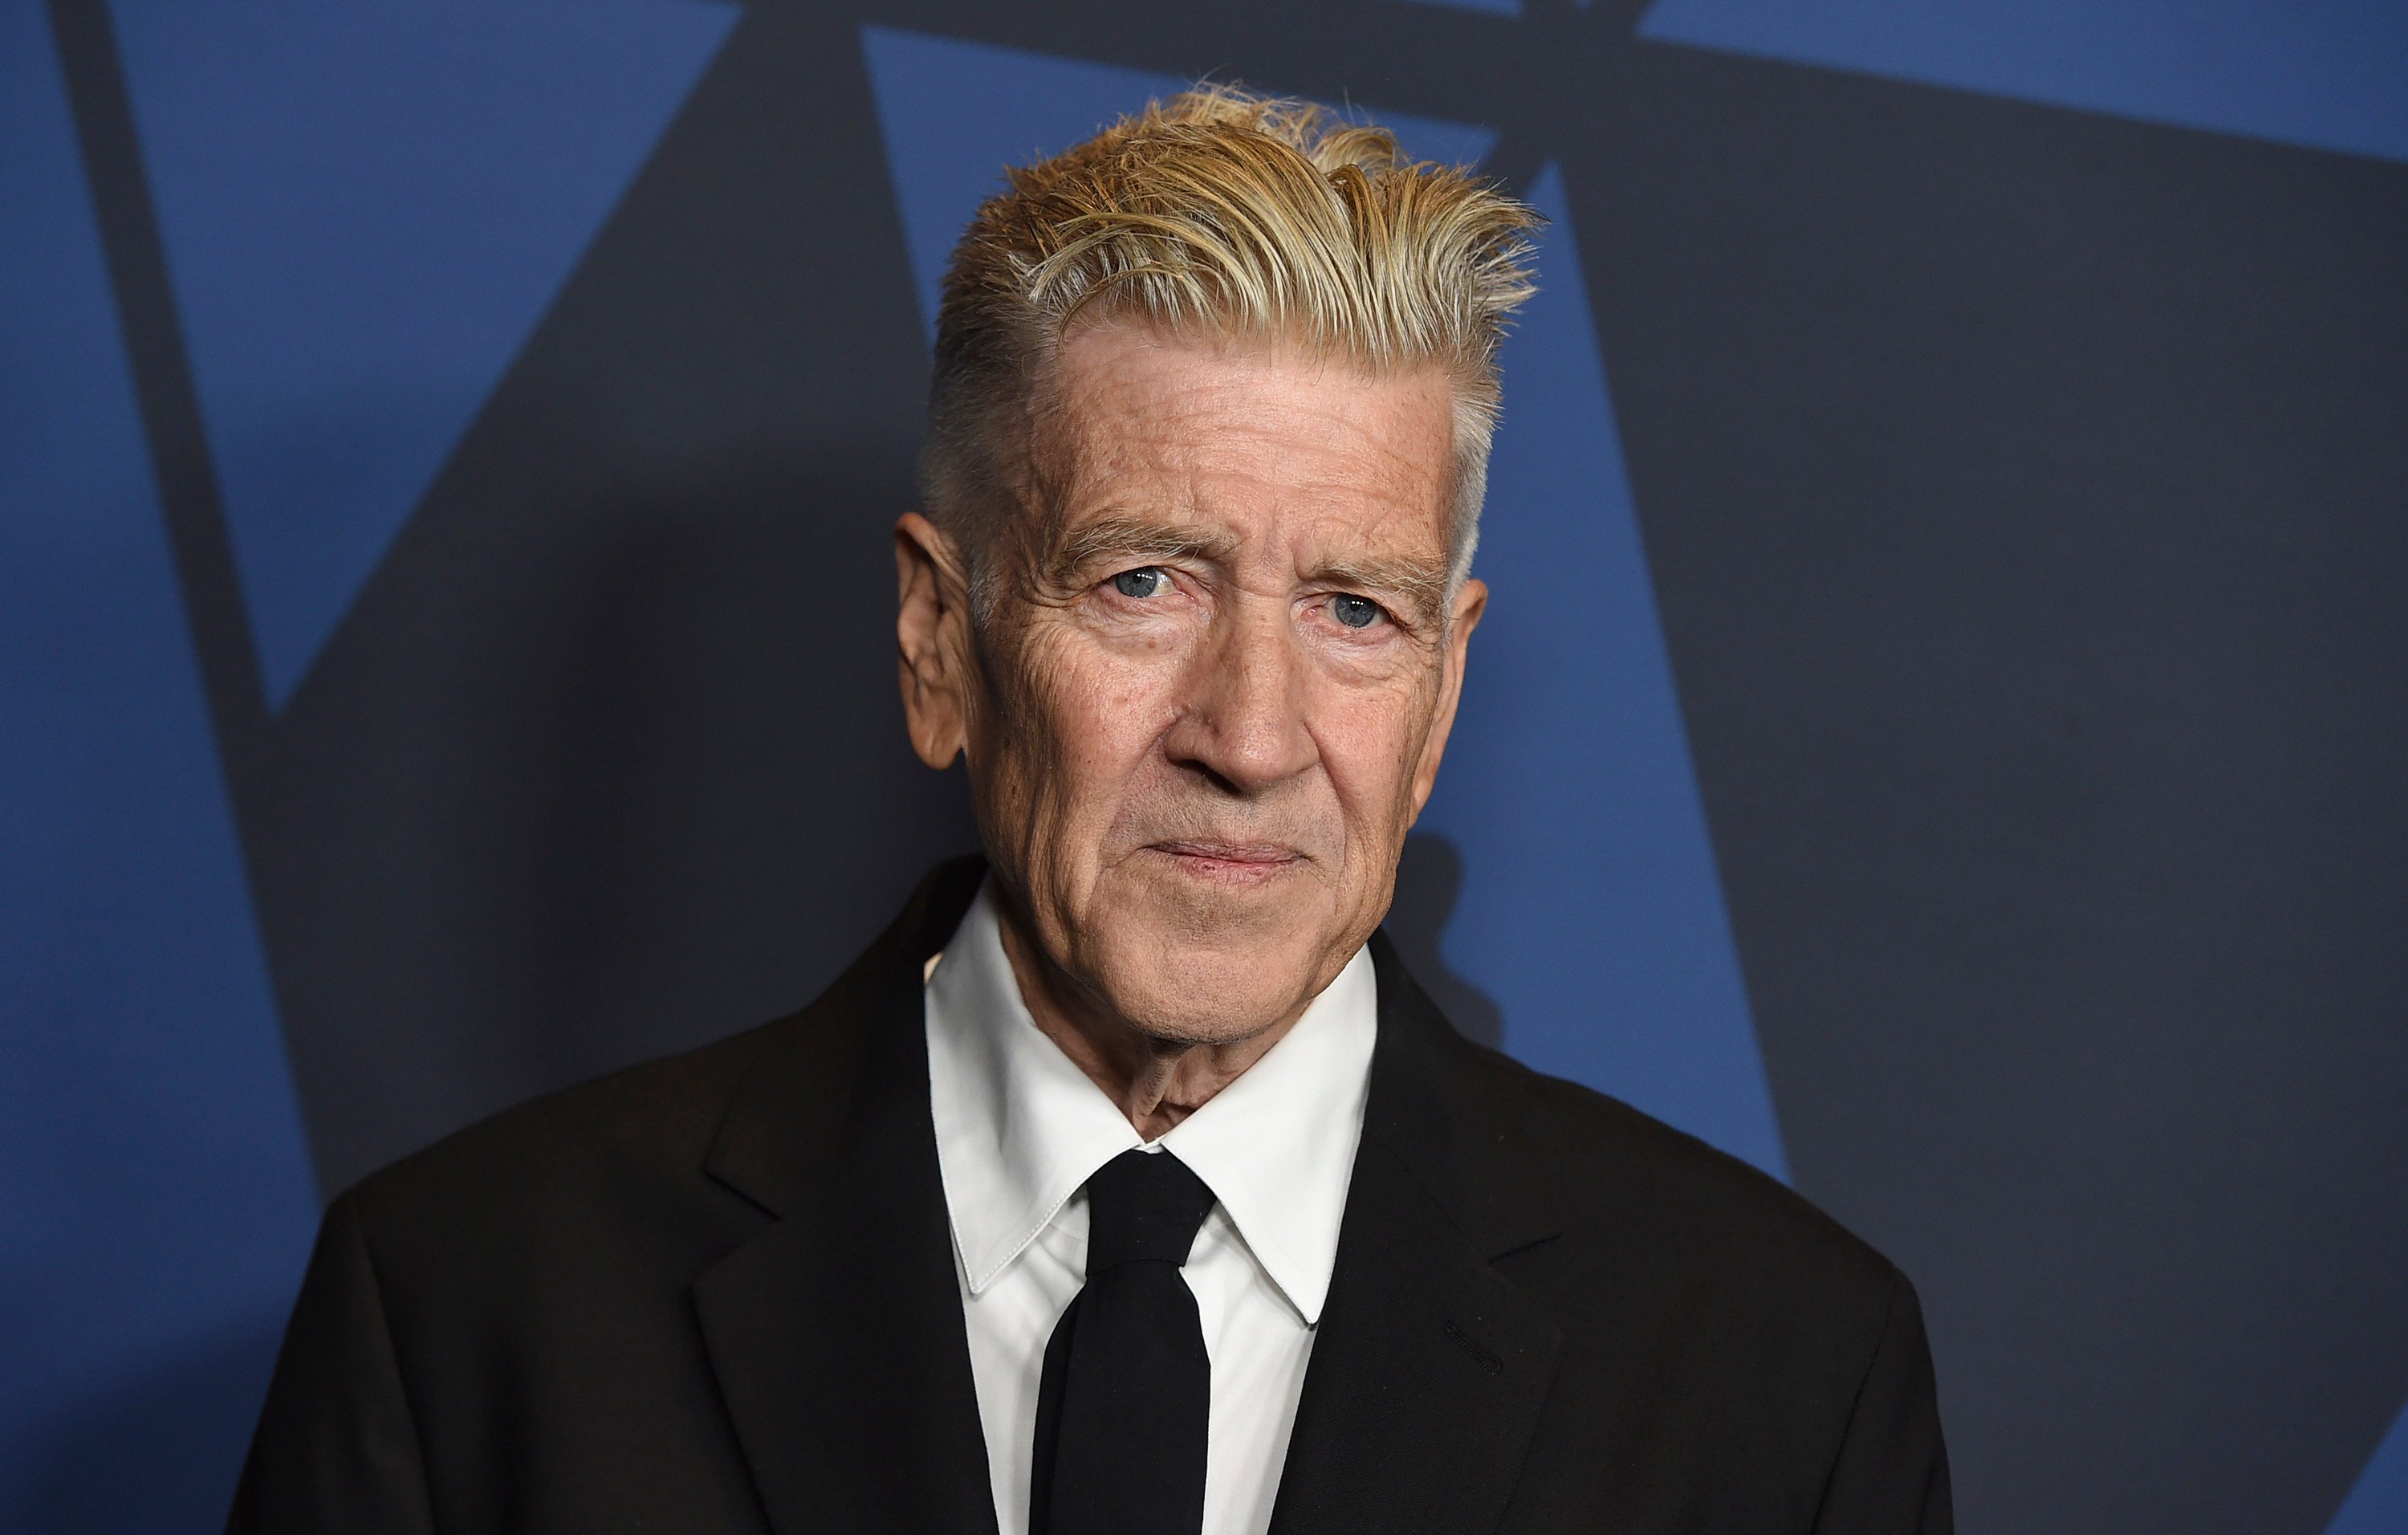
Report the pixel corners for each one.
[694,865,995,1535]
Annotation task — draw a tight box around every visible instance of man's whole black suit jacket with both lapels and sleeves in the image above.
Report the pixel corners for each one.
[231,861,1948,1535]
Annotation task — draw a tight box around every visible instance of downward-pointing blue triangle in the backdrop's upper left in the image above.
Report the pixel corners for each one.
[113,0,737,703]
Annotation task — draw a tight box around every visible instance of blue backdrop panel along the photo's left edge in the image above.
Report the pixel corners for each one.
[0,0,318,1530]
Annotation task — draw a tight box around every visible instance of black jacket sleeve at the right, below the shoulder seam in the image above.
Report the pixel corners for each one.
[1813,1275,1955,1535]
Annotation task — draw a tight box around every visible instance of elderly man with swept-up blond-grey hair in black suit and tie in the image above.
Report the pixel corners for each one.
[234,92,1948,1535]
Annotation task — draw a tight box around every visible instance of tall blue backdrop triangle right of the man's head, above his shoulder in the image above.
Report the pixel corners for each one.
[1421,166,1787,1176]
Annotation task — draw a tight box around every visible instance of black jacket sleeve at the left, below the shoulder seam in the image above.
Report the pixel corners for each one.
[226,1195,433,1535]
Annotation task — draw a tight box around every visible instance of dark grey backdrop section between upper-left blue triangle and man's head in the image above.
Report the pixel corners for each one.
[217,7,975,1193]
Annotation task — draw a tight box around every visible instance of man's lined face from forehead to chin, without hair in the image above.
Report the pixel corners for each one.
[905,325,1486,1041]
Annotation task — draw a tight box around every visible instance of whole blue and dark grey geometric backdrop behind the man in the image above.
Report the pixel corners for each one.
[0,0,2408,1535]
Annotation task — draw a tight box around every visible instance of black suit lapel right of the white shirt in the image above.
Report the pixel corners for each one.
[1271,938,1563,1535]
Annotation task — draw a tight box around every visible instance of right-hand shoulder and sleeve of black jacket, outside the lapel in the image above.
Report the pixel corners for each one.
[1416,1044,1948,1530]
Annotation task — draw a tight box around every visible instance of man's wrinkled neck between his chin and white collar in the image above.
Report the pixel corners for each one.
[997,902,1303,1140]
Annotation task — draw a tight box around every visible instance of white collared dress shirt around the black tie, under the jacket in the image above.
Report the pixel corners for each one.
[927,882,1377,1535]
